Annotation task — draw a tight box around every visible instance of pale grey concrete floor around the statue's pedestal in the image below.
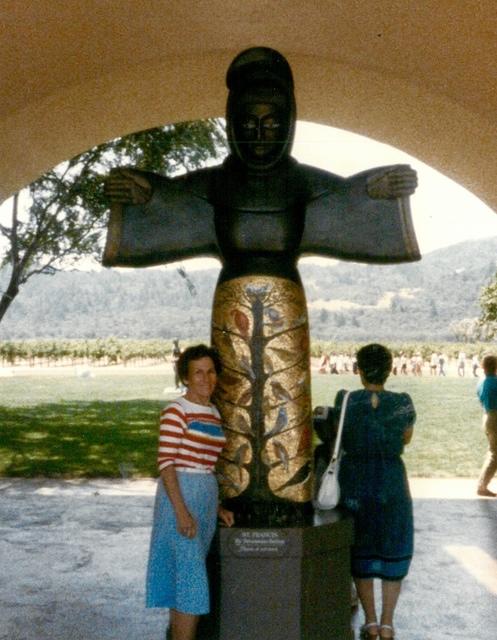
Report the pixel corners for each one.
[0,479,497,640]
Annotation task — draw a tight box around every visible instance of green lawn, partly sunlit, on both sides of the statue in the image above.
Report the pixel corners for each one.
[0,370,486,477]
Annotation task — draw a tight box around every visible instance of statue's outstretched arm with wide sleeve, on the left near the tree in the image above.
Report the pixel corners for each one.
[102,169,218,266]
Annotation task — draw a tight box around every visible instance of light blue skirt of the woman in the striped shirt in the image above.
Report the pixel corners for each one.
[146,471,218,615]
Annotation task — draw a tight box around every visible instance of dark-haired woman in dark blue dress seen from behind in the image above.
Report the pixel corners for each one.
[335,344,416,640]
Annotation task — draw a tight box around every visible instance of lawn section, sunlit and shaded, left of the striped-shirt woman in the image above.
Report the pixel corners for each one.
[0,370,169,478]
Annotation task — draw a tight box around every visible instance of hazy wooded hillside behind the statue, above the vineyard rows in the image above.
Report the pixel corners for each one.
[0,238,497,341]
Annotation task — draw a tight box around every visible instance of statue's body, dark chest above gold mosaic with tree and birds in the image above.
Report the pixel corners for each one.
[209,162,312,526]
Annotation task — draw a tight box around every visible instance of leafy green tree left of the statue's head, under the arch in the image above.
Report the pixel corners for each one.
[0,119,226,322]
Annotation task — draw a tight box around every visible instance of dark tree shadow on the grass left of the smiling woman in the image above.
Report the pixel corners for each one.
[0,400,164,478]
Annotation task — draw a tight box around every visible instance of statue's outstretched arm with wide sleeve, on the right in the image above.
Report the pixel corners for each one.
[301,165,420,263]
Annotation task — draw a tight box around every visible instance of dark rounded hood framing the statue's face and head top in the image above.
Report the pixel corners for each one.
[226,47,296,170]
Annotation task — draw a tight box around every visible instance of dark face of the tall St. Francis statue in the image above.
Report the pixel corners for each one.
[233,102,288,165]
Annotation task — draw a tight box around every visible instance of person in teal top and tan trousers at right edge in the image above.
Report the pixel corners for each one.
[477,355,497,498]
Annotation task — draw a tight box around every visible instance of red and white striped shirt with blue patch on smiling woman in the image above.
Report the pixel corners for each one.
[158,398,226,471]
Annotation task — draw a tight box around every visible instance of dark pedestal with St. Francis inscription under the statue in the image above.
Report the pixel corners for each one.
[199,511,353,640]
